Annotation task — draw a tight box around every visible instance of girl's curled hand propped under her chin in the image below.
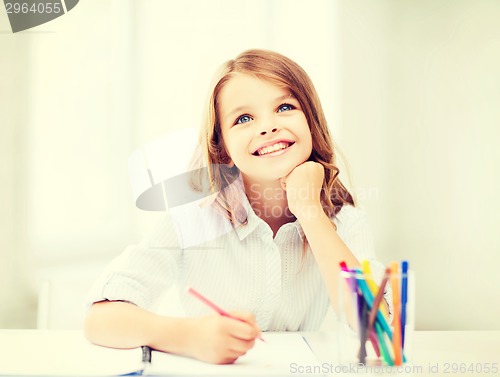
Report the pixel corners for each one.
[281,161,325,220]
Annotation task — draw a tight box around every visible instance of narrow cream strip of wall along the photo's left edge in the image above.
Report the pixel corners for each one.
[0,30,36,327]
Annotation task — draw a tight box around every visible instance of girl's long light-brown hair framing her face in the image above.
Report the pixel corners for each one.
[192,49,354,225]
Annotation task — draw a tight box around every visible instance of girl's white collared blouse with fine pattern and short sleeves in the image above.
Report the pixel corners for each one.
[88,201,390,331]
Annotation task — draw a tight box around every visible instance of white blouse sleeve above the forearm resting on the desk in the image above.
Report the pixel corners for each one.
[86,213,180,308]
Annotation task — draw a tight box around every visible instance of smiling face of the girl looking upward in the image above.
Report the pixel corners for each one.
[218,73,312,183]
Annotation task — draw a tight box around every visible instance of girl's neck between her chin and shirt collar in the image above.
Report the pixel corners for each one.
[243,178,296,236]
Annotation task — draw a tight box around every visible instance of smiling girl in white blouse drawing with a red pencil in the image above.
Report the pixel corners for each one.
[85,50,383,363]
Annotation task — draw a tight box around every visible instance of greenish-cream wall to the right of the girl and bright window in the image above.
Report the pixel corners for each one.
[341,0,500,329]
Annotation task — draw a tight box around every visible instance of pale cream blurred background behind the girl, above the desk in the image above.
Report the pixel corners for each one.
[0,0,500,330]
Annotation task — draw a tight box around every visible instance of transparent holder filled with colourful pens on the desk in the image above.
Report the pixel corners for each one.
[337,268,415,366]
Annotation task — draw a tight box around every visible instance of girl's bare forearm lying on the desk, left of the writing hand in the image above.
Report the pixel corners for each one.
[84,301,190,354]
